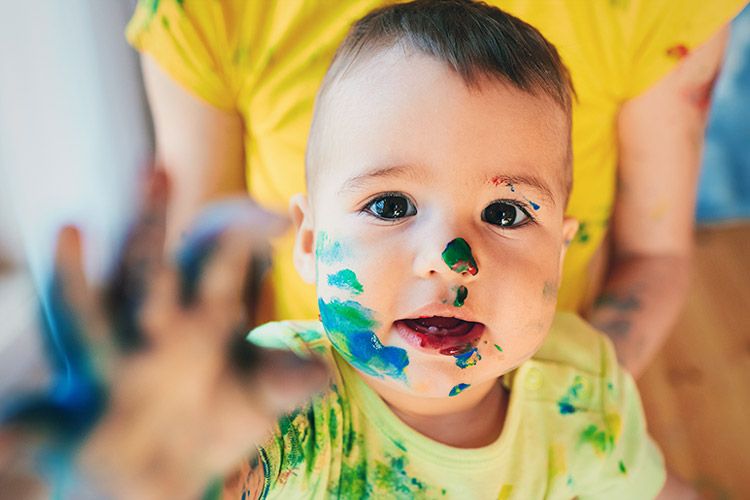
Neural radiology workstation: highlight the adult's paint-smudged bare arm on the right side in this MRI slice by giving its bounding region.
[589,28,729,377]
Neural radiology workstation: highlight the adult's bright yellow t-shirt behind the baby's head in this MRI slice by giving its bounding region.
[127,0,744,319]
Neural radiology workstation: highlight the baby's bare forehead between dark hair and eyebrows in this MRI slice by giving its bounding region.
[308,49,570,203]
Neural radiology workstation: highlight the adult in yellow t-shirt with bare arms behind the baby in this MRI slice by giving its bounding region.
[127,0,744,375]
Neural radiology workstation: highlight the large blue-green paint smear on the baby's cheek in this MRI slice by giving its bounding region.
[318,299,409,381]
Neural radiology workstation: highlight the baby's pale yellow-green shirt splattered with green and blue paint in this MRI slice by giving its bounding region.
[234,313,665,500]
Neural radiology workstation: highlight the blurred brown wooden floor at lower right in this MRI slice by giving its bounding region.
[638,223,750,500]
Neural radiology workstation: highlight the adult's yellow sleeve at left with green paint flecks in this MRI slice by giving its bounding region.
[125,0,245,110]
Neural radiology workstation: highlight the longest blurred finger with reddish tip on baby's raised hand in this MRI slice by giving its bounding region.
[105,170,169,351]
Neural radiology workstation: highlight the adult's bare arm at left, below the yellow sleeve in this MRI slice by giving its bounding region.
[141,55,245,248]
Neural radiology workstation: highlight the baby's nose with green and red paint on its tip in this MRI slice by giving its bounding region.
[414,237,479,282]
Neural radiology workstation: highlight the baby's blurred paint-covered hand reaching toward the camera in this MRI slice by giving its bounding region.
[4,172,327,499]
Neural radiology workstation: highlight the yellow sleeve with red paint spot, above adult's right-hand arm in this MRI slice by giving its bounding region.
[624,0,746,99]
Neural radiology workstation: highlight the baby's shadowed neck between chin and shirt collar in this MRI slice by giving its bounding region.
[368,377,508,448]
